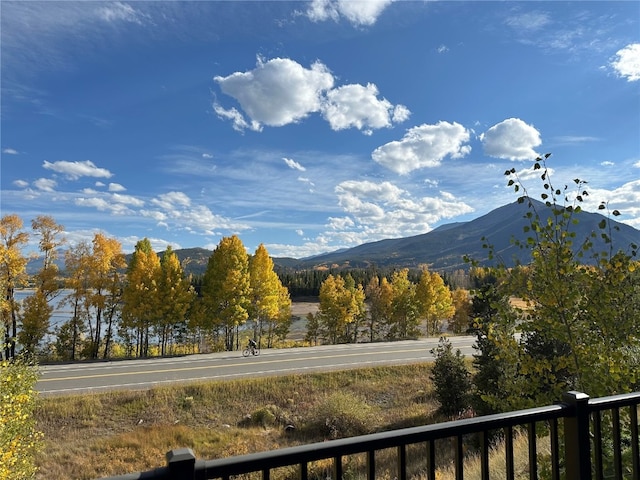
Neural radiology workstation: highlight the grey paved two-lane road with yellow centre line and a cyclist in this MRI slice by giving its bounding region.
[36,337,475,395]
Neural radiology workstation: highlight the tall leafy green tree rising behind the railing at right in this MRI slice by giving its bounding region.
[468,155,640,410]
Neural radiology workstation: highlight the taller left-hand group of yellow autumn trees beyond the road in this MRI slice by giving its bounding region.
[0,215,291,360]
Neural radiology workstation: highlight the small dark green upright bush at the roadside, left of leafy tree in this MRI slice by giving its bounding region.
[431,338,471,417]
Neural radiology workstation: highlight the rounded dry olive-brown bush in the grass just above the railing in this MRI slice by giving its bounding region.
[307,392,372,438]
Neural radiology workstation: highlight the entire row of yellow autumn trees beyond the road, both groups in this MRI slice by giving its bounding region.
[0,215,471,360]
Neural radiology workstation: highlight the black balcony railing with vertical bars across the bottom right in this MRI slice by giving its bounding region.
[101,392,640,480]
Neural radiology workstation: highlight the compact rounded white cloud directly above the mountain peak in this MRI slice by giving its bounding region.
[480,118,542,160]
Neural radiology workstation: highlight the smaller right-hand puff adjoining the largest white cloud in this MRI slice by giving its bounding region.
[322,83,410,133]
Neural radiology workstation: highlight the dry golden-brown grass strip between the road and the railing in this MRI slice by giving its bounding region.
[36,364,439,480]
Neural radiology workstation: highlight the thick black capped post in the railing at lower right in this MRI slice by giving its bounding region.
[562,391,591,479]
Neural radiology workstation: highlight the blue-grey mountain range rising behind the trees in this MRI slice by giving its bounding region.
[28,199,640,275]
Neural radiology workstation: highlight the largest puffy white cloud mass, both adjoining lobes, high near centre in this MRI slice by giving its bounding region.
[213,58,410,134]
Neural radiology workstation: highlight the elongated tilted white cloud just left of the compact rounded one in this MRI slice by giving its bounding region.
[371,121,471,174]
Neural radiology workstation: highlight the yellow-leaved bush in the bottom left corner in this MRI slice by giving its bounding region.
[0,358,42,480]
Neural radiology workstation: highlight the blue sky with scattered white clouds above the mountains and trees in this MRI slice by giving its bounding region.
[0,0,640,258]
